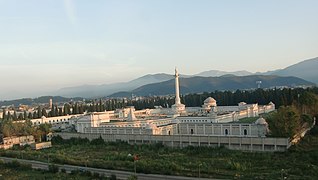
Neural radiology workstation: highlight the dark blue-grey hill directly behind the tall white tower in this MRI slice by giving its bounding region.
[111,75,314,97]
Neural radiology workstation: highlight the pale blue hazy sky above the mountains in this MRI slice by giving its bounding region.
[0,0,318,100]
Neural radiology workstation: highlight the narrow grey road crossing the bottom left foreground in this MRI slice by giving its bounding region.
[0,157,216,180]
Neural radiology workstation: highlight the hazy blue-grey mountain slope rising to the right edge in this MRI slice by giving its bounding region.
[268,57,318,84]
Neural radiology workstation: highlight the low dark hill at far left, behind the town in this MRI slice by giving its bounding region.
[0,96,83,107]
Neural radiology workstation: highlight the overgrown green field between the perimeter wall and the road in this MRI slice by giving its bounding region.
[0,126,318,179]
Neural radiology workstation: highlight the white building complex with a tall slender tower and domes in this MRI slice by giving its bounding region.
[74,69,275,137]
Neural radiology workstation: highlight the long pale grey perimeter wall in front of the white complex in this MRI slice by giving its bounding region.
[54,133,290,152]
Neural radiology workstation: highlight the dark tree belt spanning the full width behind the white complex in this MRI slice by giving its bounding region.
[3,87,318,121]
